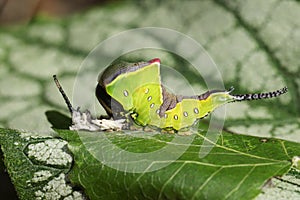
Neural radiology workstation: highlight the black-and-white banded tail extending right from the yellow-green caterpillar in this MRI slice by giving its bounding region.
[230,87,288,101]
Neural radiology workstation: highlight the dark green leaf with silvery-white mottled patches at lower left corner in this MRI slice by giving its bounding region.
[0,128,82,199]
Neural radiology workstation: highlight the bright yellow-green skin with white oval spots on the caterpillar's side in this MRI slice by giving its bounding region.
[99,60,234,130]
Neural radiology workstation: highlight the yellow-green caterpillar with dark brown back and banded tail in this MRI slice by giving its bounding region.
[96,58,287,131]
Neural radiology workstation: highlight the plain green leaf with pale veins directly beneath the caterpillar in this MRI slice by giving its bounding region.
[54,126,300,199]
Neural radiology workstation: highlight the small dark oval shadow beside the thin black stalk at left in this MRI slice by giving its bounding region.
[45,110,72,129]
